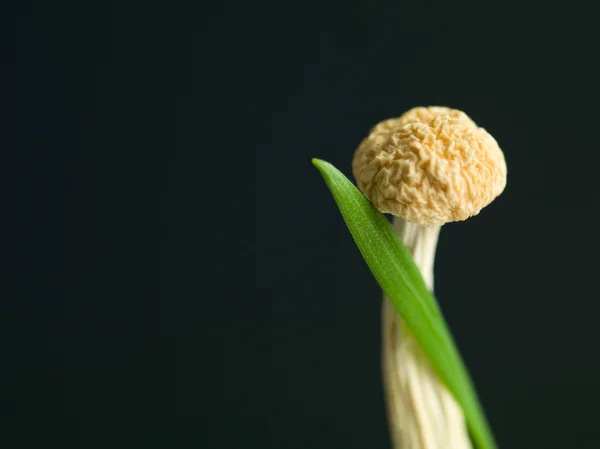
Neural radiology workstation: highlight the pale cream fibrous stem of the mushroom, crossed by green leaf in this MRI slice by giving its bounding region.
[382,217,472,449]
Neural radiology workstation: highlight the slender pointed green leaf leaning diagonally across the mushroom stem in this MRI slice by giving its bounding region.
[312,159,496,449]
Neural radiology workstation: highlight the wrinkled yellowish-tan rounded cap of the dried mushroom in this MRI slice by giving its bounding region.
[352,112,506,225]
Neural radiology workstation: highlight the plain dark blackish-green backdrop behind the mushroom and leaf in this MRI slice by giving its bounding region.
[8,1,600,449]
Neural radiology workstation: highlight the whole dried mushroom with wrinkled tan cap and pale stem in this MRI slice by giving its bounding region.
[352,106,506,449]
